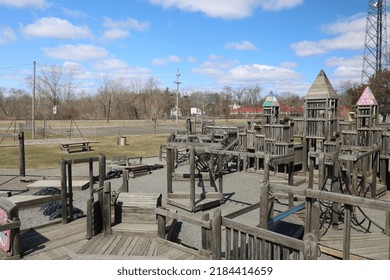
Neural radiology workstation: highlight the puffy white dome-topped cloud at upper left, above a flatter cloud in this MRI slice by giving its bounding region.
[21,17,93,39]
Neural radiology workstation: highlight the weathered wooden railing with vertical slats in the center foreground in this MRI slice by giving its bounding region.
[156,201,318,260]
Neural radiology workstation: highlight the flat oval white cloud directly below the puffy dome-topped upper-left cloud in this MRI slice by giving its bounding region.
[43,44,108,61]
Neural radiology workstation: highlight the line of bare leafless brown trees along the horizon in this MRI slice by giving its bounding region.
[0,66,314,123]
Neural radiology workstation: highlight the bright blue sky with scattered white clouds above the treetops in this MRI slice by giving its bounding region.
[0,0,380,96]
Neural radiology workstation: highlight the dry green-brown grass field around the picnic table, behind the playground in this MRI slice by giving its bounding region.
[0,119,246,169]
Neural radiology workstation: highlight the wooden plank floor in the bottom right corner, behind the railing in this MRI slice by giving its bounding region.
[319,230,390,260]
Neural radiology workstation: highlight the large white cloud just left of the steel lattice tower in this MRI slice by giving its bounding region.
[291,14,366,56]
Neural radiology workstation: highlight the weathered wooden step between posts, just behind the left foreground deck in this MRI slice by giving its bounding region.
[111,192,162,236]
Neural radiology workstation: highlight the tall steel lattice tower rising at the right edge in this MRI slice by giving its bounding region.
[362,0,389,84]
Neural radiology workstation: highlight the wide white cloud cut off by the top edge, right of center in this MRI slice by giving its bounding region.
[149,0,303,19]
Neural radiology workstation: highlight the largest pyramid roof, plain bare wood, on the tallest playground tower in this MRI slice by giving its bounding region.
[304,70,338,99]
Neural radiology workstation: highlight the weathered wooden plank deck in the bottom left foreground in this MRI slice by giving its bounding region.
[8,218,208,260]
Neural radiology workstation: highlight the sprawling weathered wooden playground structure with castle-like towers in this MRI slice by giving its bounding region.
[0,71,390,260]
